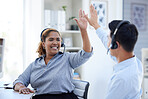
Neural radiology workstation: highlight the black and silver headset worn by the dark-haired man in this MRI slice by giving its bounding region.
[107,21,130,54]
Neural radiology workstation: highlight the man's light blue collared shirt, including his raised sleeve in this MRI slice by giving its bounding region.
[96,28,143,99]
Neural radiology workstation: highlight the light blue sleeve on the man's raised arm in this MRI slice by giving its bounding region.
[96,27,117,62]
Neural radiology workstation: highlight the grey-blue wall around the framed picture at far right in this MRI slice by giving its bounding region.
[124,0,148,59]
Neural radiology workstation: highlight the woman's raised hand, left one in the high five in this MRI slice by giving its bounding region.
[74,9,87,30]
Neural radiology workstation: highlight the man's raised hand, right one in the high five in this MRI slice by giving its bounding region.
[84,4,100,29]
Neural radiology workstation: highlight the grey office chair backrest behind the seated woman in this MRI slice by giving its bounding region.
[73,80,89,99]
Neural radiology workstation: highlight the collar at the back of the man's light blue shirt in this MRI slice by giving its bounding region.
[113,56,136,72]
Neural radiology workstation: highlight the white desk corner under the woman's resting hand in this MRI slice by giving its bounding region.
[0,88,33,99]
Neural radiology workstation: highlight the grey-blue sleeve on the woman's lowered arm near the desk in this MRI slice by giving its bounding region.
[13,64,32,87]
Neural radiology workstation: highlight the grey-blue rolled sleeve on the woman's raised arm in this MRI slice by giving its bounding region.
[69,48,93,69]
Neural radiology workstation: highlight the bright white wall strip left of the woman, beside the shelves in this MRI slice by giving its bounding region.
[23,0,44,69]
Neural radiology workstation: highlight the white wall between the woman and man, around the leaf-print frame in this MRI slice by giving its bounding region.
[81,0,122,99]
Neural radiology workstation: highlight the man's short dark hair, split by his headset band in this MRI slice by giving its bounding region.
[109,20,138,52]
